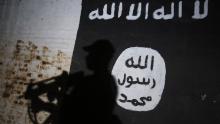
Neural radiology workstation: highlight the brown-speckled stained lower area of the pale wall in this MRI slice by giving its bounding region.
[0,40,71,124]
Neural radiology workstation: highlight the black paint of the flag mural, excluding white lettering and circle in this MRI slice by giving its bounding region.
[71,0,220,124]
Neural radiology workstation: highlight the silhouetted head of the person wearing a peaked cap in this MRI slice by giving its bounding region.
[84,39,114,72]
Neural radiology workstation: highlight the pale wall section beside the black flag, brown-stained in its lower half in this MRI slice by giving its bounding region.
[0,0,81,124]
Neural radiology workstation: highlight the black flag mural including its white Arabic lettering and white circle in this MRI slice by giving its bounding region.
[70,0,220,124]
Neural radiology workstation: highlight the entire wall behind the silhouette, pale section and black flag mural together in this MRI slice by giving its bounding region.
[0,0,220,124]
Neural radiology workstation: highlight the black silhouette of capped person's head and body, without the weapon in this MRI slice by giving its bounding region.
[60,40,120,124]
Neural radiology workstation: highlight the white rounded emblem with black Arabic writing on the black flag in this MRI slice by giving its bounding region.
[112,47,166,111]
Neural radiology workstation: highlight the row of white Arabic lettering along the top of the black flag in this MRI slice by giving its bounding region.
[88,0,208,21]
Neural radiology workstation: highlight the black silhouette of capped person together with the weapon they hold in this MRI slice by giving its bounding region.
[25,40,121,124]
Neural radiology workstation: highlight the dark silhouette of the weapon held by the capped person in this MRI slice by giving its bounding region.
[21,71,69,124]
